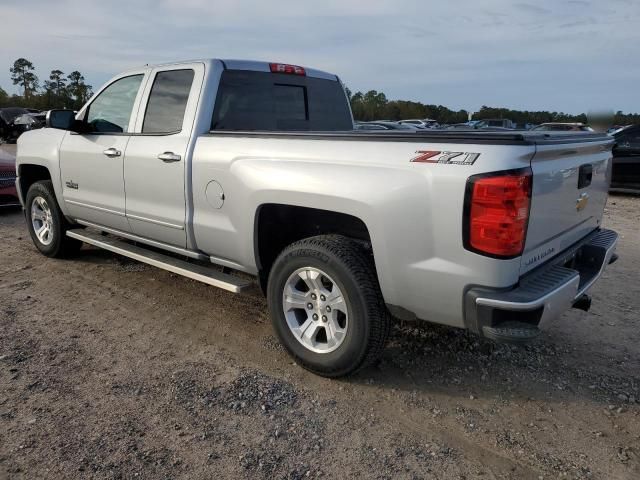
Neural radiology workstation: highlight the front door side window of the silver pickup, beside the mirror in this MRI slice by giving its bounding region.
[85,75,144,133]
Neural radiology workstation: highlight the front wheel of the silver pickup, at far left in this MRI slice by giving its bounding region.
[25,180,82,258]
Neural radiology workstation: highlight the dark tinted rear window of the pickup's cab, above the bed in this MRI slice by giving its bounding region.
[211,70,353,131]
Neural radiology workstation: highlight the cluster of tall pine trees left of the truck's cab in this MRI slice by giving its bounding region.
[0,58,93,110]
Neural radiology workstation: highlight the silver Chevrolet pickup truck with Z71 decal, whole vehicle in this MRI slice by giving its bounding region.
[16,60,617,376]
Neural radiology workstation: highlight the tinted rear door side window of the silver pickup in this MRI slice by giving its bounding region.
[142,70,194,133]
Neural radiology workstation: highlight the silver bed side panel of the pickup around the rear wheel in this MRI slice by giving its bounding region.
[192,134,533,326]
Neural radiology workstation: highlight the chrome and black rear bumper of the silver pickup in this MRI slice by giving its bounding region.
[465,230,618,341]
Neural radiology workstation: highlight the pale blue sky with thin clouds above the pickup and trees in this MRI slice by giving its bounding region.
[0,0,640,113]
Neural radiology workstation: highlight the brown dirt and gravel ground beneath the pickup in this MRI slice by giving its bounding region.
[0,144,640,479]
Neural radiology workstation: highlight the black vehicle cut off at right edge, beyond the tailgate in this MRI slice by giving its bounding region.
[611,125,640,193]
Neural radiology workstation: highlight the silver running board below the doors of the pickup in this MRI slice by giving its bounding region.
[67,228,253,293]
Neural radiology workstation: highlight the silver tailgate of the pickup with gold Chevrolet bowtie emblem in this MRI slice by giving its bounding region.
[520,134,612,274]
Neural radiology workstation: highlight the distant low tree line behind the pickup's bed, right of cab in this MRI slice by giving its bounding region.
[347,88,640,125]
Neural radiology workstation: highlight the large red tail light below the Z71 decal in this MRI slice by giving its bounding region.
[463,168,532,258]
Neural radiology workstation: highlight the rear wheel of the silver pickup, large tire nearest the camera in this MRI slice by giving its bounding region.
[267,235,390,377]
